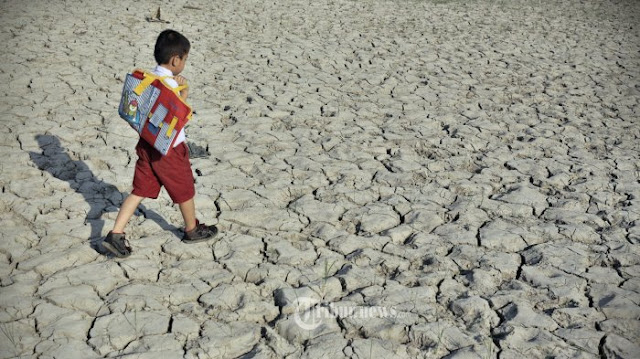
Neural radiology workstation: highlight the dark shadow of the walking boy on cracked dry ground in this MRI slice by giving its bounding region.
[29,135,177,254]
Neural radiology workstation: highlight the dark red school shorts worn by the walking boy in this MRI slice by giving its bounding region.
[131,138,196,203]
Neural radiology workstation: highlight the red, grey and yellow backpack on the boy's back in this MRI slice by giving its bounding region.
[118,70,192,155]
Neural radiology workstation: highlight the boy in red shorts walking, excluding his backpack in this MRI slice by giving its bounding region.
[102,30,218,257]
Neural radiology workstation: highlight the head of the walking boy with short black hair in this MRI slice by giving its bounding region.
[153,30,191,75]
